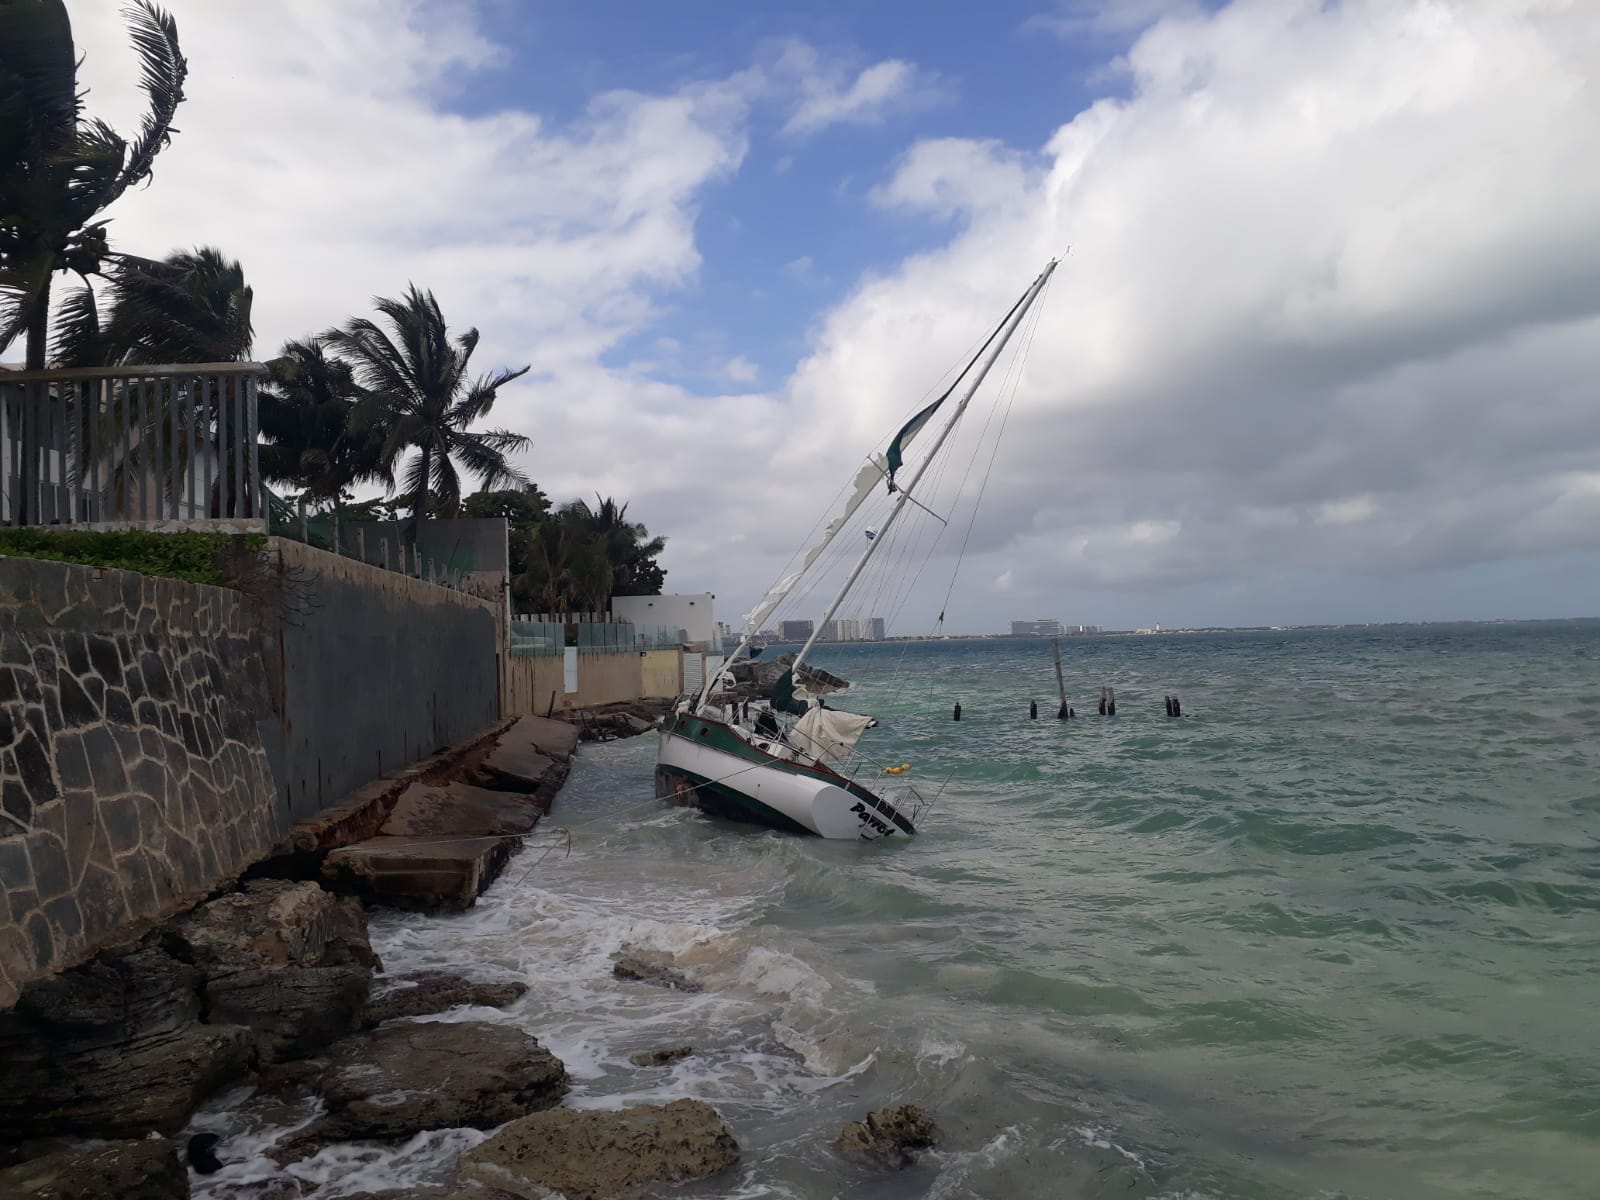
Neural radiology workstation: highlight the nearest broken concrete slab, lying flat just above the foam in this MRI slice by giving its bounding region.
[322,837,522,910]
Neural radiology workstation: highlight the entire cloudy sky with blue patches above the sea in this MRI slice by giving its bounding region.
[69,0,1600,632]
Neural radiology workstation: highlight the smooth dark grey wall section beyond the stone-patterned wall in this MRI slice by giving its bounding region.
[266,538,496,819]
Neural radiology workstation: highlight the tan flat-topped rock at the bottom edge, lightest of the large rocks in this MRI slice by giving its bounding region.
[456,1099,739,1200]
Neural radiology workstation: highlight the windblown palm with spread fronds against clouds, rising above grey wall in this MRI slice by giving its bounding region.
[323,283,528,541]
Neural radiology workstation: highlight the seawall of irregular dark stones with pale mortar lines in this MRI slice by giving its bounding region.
[0,557,290,1010]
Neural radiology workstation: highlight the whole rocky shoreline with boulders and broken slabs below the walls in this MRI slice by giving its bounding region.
[0,714,933,1200]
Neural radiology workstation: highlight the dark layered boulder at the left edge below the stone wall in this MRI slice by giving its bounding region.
[0,946,256,1141]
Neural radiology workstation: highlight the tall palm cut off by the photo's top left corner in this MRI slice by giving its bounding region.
[0,0,189,370]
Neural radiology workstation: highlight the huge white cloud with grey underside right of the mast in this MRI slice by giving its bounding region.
[768,0,1600,627]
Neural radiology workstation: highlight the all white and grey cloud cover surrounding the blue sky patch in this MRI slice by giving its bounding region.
[65,0,1600,629]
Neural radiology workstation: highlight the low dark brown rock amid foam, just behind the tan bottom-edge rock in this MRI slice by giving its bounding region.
[272,1021,570,1162]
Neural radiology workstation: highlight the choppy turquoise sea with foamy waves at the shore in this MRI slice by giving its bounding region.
[196,622,1600,1200]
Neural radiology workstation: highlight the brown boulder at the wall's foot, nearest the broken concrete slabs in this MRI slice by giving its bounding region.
[170,880,378,1062]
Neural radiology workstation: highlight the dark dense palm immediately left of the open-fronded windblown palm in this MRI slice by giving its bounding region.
[259,338,394,499]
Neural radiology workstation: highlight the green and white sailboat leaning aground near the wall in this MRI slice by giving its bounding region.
[656,259,1056,842]
